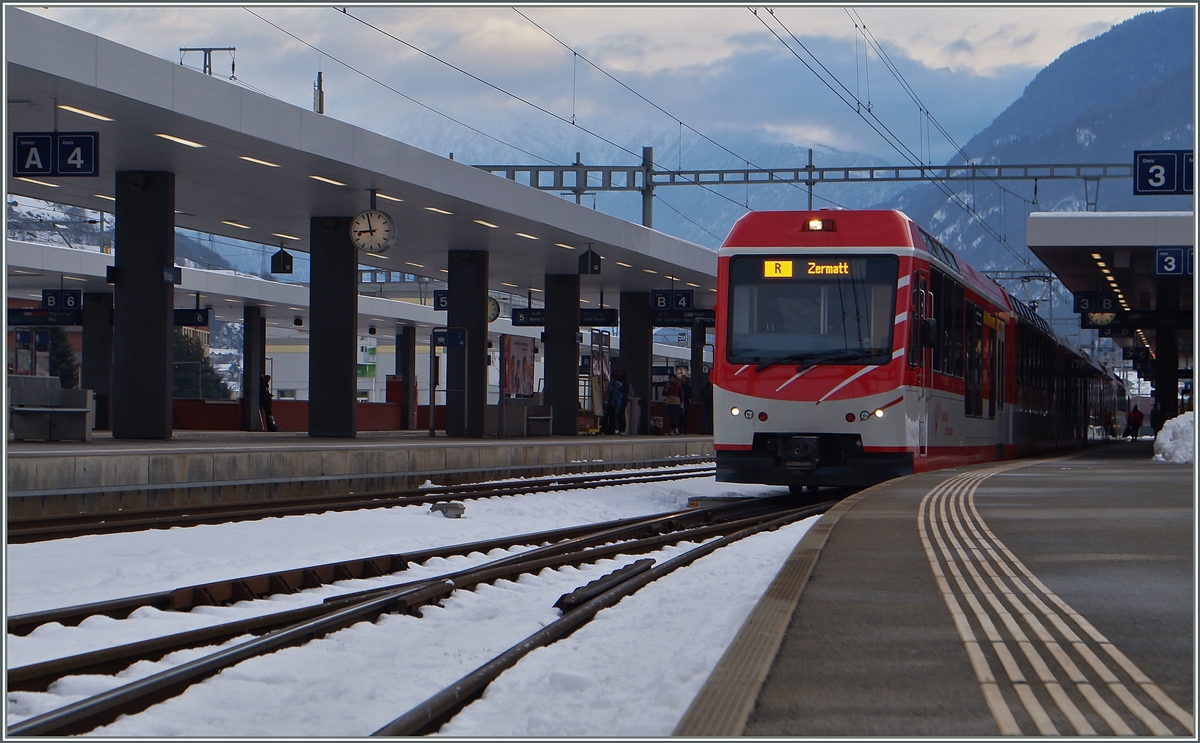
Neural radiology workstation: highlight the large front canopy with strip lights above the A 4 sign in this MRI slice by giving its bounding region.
[5,7,716,306]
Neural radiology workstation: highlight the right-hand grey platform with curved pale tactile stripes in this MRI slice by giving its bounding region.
[676,442,1195,737]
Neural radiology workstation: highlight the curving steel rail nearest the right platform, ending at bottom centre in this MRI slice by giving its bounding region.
[371,503,833,736]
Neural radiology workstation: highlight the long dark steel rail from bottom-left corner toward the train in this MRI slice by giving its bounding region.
[7,496,811,736]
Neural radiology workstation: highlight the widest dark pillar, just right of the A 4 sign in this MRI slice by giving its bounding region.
[109,170,175,438]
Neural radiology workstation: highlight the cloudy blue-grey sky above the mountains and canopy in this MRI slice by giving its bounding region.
[31,5,1158,167]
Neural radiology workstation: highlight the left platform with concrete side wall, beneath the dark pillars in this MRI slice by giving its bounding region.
[6,431,713,520]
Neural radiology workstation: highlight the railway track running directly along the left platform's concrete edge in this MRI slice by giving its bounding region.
[7,465,715,544]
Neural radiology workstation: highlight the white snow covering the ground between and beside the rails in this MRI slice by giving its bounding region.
[6,478,815,737]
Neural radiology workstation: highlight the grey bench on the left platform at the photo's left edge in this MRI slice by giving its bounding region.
[8,375,95,442]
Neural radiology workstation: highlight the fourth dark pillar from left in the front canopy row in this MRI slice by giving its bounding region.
[542,274,580,436]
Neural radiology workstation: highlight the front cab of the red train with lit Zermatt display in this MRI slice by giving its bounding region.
[714,212,932,490]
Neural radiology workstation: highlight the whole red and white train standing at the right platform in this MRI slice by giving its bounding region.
[712,210,1126,492]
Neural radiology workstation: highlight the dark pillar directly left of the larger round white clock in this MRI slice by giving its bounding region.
[308,217,359,438]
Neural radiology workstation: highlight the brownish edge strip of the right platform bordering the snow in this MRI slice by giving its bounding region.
[671,475,913,737]
